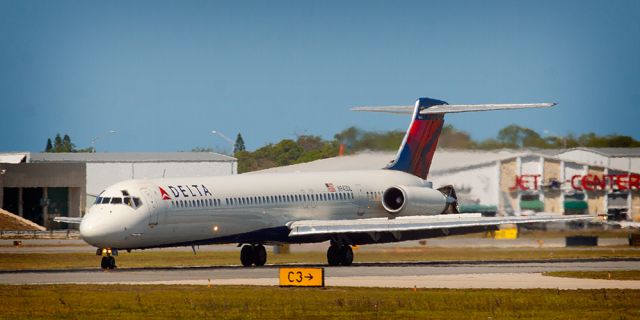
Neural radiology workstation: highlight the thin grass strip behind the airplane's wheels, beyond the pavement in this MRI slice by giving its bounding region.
[0,247,640,270]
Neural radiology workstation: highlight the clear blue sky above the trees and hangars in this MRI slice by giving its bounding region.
[0,0,640,152]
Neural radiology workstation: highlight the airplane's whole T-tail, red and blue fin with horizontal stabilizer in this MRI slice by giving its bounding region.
[351,98,556,179]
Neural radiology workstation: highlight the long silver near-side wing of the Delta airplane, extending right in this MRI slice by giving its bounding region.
[288,213,594,237]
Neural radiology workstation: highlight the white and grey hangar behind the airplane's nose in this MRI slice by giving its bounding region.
[0,152,238,227]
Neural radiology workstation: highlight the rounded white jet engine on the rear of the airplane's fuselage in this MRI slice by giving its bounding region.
[382,186,451,216]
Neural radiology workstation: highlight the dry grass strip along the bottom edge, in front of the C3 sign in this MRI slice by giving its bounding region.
[0,285,640,320]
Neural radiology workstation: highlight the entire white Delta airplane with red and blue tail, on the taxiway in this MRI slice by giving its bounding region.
[56,98,592,269]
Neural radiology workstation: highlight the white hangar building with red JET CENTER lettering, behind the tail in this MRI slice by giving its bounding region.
[256,148,640,221]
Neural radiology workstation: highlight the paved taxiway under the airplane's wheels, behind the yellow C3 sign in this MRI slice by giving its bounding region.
[5,259,640,290]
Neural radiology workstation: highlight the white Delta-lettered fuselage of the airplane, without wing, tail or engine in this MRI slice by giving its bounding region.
[80,170,444,249]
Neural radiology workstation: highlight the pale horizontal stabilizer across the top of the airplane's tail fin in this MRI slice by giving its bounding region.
[351,103,556,114]
